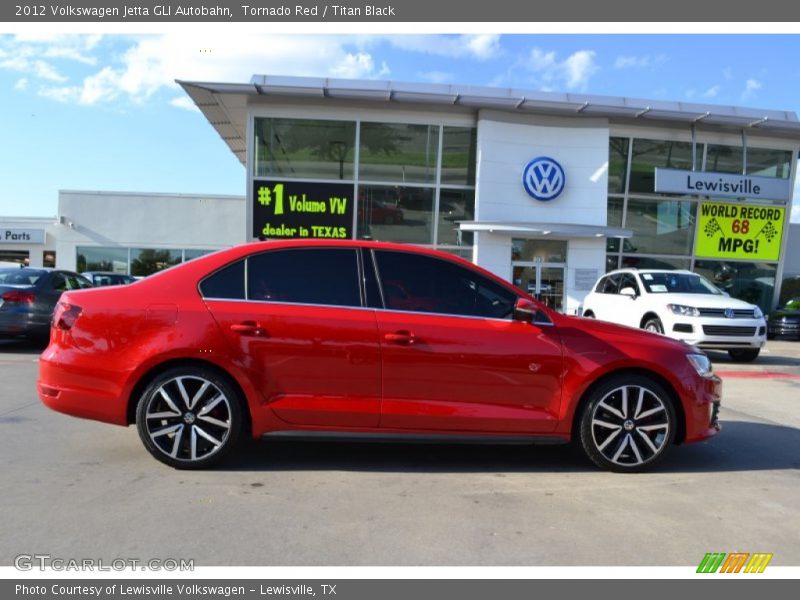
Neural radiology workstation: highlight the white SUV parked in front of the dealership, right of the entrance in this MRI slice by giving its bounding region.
[581,269,767,361]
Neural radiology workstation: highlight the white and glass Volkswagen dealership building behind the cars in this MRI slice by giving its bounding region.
[0,75,800,314]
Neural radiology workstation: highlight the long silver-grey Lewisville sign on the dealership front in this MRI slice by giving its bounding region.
[655,168,792,200]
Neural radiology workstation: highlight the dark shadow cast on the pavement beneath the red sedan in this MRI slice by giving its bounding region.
[219,421,800,473]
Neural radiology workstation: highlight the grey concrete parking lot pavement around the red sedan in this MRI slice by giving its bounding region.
[0,342,800,566]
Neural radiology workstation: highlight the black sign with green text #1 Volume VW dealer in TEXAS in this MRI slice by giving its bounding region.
[252,179,353,240]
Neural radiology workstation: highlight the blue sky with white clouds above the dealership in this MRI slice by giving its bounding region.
[0,30,800,222]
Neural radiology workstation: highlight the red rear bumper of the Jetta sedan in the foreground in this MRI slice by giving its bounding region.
[36,348,128,425]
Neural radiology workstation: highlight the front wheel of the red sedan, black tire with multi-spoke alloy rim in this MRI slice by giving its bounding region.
[578,374,677,473]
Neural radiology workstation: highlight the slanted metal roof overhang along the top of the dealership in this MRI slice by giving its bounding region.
[178,75,800,169]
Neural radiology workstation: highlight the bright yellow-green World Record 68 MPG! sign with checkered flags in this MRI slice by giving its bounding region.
[695,202,786,261]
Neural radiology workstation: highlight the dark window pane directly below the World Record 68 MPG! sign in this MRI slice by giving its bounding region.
[694,260,778,313]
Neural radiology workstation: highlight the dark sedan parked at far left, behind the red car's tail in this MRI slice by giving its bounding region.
[0,267,92,339]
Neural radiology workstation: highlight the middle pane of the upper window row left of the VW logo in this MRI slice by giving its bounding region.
[358,123,439,184]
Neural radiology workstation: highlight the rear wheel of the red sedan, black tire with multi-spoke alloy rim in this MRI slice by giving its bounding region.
[136,366,244,469]
